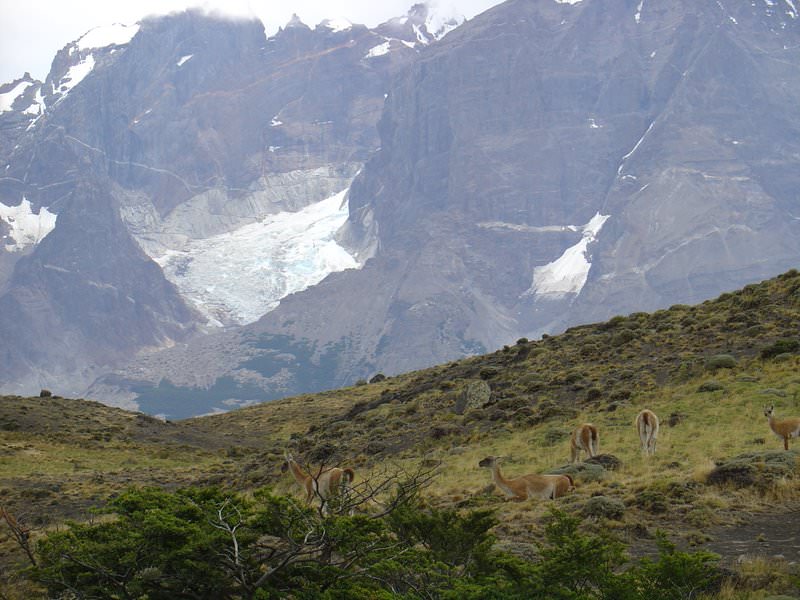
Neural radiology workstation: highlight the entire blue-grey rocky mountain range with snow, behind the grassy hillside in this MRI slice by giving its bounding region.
[0,0,800,417]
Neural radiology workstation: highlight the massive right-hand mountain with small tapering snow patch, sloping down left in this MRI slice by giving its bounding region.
[101,0,800,414]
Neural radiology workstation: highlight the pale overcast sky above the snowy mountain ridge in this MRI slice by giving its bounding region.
[0,0,500,84]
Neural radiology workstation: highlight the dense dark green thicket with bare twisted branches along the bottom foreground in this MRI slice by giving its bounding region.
[30,484,716,600]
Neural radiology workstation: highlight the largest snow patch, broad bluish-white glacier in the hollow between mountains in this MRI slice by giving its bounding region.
[154,190,360,326]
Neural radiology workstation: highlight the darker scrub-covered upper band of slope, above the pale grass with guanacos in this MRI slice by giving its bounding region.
[211,271,800,461]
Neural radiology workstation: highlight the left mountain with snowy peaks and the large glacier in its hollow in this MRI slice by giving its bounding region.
[0,6,444,393]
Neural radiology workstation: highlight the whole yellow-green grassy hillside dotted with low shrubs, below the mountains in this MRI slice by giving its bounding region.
[0,271,800,587]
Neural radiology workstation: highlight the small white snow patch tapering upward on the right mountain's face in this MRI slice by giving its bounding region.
[523,212,609,299]
